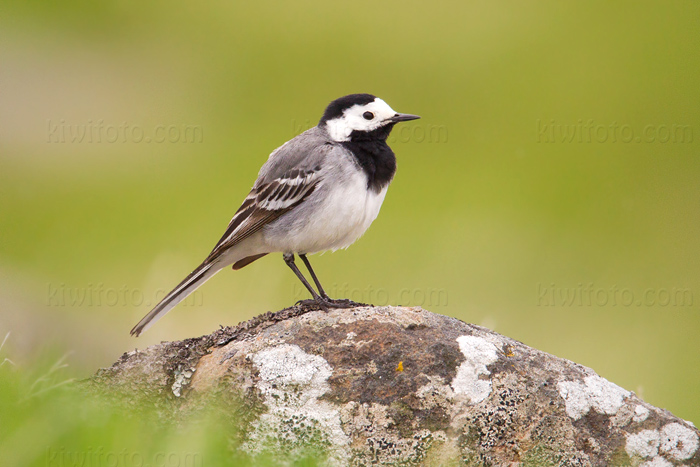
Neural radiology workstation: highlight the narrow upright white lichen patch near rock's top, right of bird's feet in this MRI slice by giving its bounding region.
[451,336,498,404]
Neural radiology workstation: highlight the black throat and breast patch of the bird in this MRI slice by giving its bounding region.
[340,123,396,193]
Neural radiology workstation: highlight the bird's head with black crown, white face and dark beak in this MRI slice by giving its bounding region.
[318,94,420,142]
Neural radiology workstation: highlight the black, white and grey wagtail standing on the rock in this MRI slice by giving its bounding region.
[131,94,420,336]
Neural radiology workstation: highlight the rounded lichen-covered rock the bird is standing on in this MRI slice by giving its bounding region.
[89,307,700,466]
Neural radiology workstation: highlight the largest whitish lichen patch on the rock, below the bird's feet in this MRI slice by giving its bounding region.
[244,344,348,464]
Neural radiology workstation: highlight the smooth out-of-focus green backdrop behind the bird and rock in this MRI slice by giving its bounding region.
[0,1,700,432]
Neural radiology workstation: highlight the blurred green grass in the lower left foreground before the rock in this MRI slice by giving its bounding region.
[0,346,323,467]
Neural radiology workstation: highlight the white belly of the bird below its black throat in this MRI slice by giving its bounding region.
[264,172,387,253]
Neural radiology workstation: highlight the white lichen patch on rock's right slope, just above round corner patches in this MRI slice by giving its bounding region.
[557,375,630,420]
